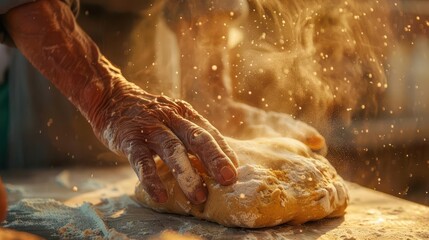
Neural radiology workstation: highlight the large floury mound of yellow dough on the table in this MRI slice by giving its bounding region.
[135,138,349,228]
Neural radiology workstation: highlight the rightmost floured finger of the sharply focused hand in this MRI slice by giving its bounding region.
[170,115,237,185]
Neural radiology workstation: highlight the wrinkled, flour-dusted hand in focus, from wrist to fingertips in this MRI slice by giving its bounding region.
[89,80,237,204]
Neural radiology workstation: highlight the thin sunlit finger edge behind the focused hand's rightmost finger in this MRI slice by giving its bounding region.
[192,116,238,167]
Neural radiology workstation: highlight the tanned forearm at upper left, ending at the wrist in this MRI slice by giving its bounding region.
[3,0,123,120]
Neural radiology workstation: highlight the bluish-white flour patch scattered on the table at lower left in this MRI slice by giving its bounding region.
[3,198,129,239]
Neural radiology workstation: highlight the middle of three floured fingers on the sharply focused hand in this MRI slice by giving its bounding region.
[148,125,207,204]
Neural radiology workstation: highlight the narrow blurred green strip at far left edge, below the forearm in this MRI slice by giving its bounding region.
[0,77,9,169]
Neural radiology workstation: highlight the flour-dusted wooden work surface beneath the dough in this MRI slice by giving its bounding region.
[1,166,429,240]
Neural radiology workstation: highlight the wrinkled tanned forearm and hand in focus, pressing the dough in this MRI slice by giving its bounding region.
[2,0,237,204]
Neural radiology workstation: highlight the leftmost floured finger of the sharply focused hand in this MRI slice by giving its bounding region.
[124,141,168,203]
